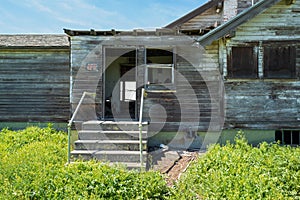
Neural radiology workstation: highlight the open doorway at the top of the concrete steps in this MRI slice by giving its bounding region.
[103,48,136,120]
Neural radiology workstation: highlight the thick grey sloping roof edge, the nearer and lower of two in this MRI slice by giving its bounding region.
[197,0,281,46]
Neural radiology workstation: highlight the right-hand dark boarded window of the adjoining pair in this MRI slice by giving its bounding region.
[264,46,296,78]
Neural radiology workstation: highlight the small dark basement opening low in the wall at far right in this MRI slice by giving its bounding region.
[275,130,300,145]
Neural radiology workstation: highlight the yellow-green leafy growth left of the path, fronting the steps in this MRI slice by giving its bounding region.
[0,127,170,199]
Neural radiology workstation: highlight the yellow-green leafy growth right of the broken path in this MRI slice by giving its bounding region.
[174,131,300,199]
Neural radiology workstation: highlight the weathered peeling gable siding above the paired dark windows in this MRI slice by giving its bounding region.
[232,0,300,42]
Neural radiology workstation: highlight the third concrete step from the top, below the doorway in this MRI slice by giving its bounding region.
[75,140,147,151]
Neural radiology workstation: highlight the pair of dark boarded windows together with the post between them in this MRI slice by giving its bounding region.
[225,41,297,79]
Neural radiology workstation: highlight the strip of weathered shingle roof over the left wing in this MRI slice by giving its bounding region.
[0,34,70,47]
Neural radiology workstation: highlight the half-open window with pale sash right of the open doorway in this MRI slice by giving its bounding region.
[145,49,175,89]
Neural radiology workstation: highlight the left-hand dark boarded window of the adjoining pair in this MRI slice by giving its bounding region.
[228,47,257,78]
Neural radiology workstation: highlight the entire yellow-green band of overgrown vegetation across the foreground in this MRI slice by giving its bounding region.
[0,127,300,199]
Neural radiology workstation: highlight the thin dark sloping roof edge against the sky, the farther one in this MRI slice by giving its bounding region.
[165,0,224,28]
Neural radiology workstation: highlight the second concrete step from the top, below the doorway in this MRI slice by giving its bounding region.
[78,130,147,140]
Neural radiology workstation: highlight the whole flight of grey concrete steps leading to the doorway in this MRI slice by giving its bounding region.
[71,120,149,169]
